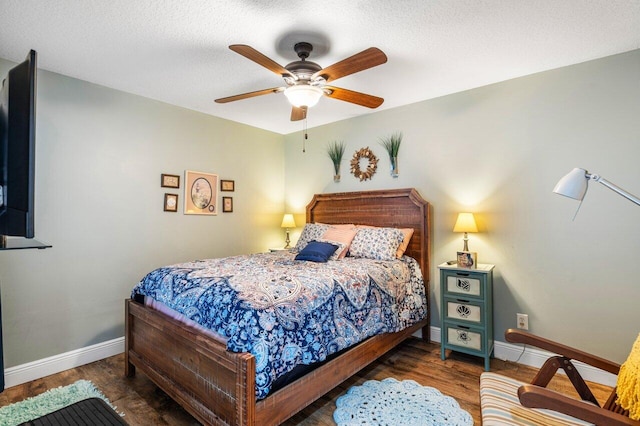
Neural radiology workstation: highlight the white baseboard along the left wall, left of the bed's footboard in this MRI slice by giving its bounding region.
[4,337,124,388]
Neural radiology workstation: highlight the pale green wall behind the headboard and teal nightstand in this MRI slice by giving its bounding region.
[285,50,640,361]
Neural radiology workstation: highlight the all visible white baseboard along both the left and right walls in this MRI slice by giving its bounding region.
[4,327,616,388]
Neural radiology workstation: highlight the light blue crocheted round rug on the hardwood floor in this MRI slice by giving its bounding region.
[333,378,473,426]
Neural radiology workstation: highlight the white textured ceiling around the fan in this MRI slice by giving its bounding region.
[0,0,640,134]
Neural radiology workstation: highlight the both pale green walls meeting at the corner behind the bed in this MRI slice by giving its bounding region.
[0,51,640,367]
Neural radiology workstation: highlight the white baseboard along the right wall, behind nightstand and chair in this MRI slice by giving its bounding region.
[420,327,617,387]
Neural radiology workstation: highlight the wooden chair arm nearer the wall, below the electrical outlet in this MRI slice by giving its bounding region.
[504,328,620,375]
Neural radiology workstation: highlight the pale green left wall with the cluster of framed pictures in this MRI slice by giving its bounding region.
[0,60,284,367]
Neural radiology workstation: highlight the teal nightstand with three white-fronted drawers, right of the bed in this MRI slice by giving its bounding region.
[438,263,495,371]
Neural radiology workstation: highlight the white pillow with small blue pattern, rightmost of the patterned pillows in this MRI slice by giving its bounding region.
[349,228,404,260]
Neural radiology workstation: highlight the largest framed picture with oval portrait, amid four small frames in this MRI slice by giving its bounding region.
[184,170,218,216]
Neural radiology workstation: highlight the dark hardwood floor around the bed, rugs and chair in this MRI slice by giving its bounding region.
[0,338,611,426]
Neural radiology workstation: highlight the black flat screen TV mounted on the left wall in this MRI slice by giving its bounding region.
[0,50,37,241]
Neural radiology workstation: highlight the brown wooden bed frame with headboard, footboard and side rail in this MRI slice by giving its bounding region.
[125,189,430,426]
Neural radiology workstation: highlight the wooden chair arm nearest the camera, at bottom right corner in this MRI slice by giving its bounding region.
[518,385,640,426]
